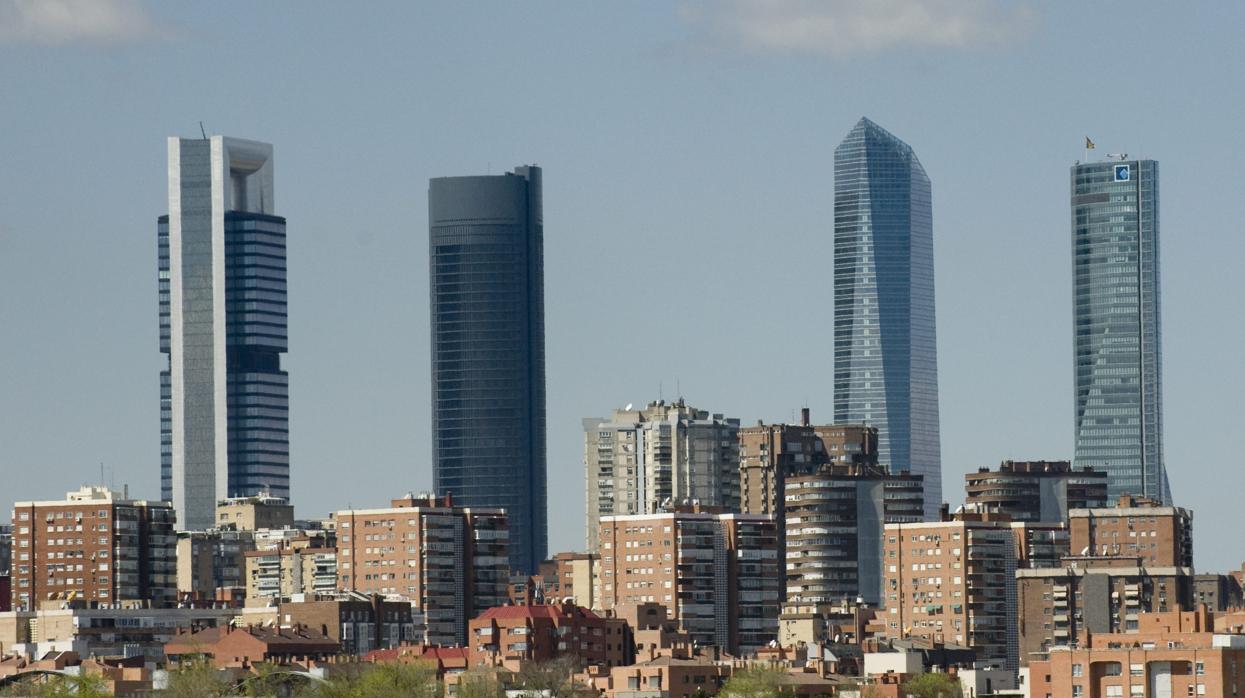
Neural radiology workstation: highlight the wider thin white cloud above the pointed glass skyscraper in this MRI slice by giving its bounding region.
[682,0,1032,56]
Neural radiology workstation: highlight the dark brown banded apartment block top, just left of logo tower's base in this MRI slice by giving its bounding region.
[964,460,1107,524]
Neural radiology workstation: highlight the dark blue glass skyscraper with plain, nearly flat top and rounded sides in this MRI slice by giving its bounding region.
[428,167,548,574]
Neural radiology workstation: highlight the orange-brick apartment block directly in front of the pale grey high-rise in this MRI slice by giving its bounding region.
[596,506,782,653]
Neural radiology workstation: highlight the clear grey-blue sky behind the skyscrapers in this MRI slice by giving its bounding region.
[0,0,1245,571]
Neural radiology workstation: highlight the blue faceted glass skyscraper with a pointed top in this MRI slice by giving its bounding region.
[834,118,942,519]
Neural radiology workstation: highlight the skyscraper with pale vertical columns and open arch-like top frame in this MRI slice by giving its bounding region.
[157,136,290,530]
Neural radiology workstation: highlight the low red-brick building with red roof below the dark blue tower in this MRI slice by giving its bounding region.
[468,603,635,668]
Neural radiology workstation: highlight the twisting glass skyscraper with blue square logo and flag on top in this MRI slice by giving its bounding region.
[1072,161,1172,504]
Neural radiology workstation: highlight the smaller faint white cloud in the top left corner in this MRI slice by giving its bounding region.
[0,0,167,45]
